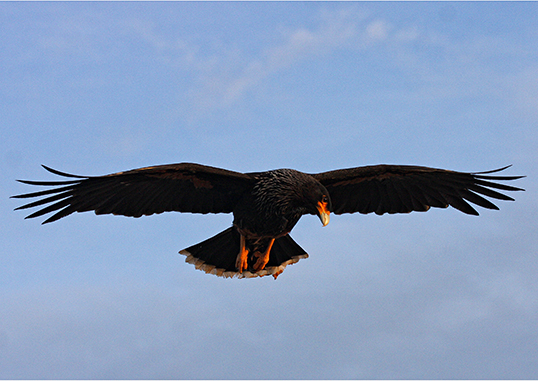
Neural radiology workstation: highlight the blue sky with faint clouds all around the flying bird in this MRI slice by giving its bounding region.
[0,2,538,379]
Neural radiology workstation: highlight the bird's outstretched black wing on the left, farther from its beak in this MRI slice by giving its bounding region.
[13,163,253,223]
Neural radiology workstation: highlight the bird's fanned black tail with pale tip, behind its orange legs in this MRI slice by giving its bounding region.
[179,227,308,279]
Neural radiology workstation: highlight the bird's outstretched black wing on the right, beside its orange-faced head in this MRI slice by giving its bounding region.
[312,165,524,215]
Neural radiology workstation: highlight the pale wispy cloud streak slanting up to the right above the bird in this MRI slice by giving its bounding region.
[182,8,417,113]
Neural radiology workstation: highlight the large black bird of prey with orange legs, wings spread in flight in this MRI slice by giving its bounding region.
[12,163,525,279]
